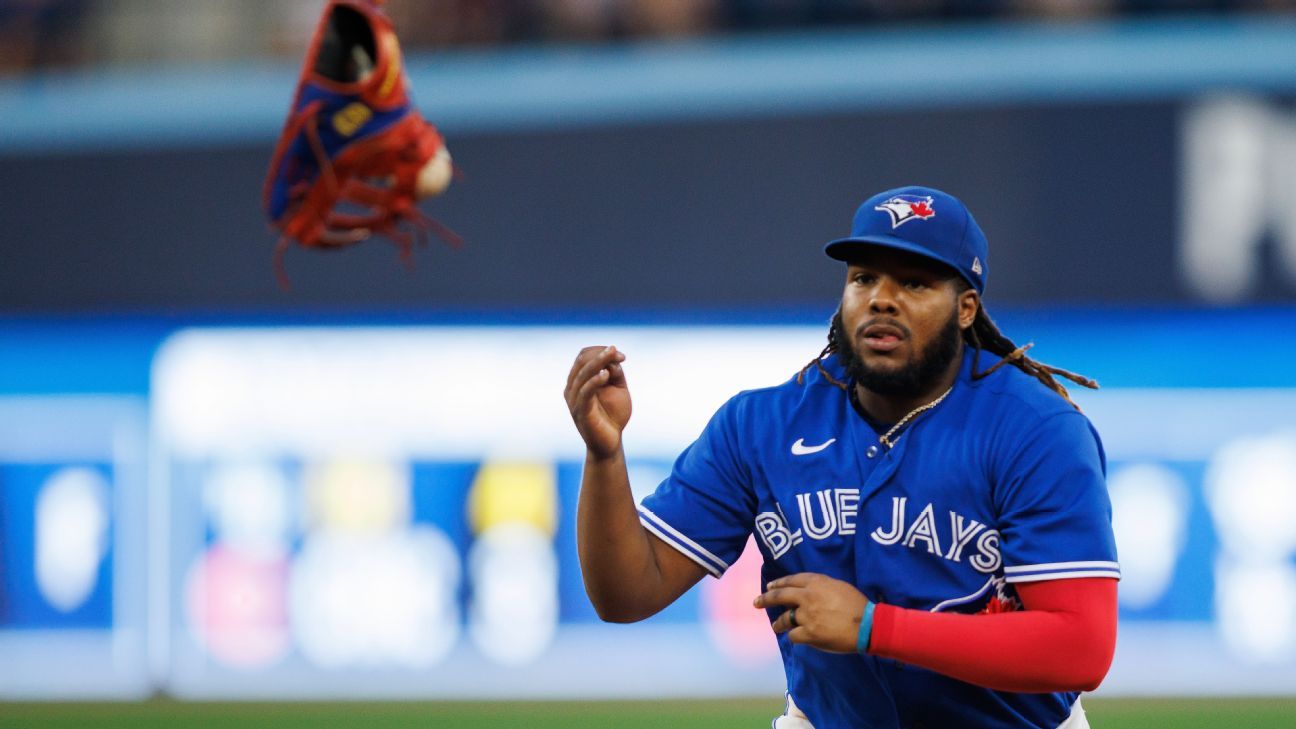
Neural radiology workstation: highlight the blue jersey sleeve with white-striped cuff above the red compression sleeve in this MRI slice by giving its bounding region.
[995,411,1121,582]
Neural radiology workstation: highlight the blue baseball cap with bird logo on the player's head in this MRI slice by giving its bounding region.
[823,187,990,294]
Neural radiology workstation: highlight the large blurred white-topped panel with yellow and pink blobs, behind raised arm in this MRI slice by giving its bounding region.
[153,327,803,698]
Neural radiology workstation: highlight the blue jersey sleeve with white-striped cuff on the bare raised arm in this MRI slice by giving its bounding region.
[639,400,756,577]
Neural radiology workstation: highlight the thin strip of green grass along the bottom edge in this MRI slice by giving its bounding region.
[0,698,1296,729]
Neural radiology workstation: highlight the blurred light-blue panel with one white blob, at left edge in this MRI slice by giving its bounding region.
[0,396,153,698]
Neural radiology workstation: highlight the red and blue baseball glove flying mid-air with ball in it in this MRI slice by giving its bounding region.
[263,0,460,288]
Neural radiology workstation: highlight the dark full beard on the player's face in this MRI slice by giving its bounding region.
[832,309,963,397]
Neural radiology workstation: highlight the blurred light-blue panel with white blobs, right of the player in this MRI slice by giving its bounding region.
[1078,388,1296,695]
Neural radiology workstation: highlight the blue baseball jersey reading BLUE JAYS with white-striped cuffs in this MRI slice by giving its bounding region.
[639,350,1120,729]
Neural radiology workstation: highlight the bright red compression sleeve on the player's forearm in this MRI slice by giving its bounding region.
[868,577,1116,693]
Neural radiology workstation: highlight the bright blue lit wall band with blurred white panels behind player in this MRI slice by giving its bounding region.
[0,307,1296,698]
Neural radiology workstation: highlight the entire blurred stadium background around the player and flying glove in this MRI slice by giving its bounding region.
[0,0,1296,728]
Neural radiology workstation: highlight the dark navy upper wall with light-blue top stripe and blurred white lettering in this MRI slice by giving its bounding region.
[0,17,1296,308]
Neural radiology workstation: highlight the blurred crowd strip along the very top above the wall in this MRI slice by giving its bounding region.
[0,0,1296,74]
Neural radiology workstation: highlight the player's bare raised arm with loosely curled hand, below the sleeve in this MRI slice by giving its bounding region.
[564,346,706,623]
